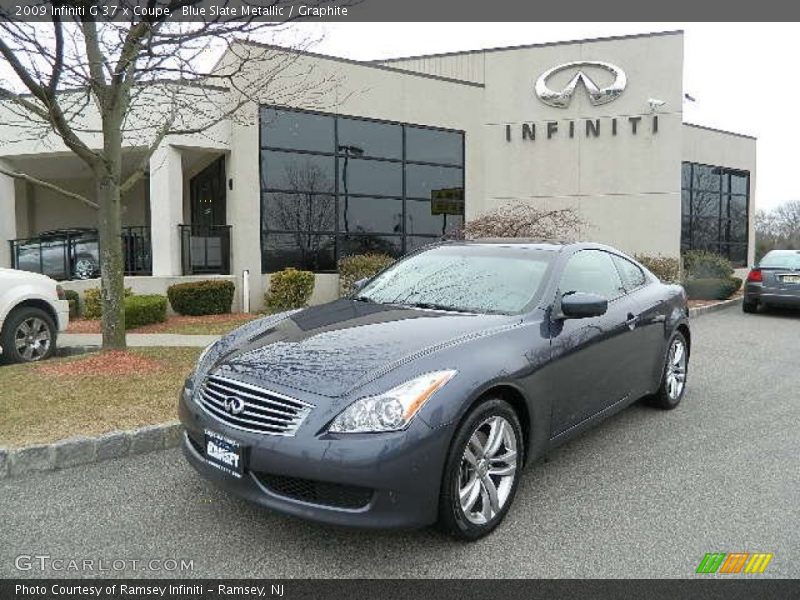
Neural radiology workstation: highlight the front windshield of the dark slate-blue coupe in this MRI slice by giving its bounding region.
[356,244,555,313]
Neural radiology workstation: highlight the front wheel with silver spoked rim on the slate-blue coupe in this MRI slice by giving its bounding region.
[439,399,524,541]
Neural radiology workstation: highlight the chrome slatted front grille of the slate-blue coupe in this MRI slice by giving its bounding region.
[198,375,313,435]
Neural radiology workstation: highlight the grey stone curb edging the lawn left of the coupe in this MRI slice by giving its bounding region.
[0,421,183,480]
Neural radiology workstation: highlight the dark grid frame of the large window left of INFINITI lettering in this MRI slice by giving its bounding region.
[258,104,467,273]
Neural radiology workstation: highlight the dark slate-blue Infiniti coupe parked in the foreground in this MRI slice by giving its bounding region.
[179,240,690,540]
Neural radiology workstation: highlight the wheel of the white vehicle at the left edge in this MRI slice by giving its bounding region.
[0,306,56,363]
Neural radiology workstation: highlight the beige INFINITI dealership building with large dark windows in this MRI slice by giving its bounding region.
[0,32,756,309]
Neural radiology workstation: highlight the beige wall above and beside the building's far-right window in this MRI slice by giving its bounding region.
[683,124,756,265]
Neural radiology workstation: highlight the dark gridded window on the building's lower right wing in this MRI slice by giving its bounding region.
[681,162,750,267]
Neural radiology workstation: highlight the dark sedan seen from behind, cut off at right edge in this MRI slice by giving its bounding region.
[742,250,800,313]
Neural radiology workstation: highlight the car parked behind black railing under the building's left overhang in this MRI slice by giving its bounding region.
[16,227,100,279]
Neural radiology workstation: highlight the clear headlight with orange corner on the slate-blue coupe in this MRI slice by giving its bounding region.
[329,370,457,433]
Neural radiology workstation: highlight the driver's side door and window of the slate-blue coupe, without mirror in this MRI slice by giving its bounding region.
[548,249,635,437]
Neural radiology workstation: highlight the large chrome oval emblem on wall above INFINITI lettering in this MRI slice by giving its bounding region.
[534,60,628,108]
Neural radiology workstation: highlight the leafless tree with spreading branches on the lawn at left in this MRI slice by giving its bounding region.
[0,0,338,348]
